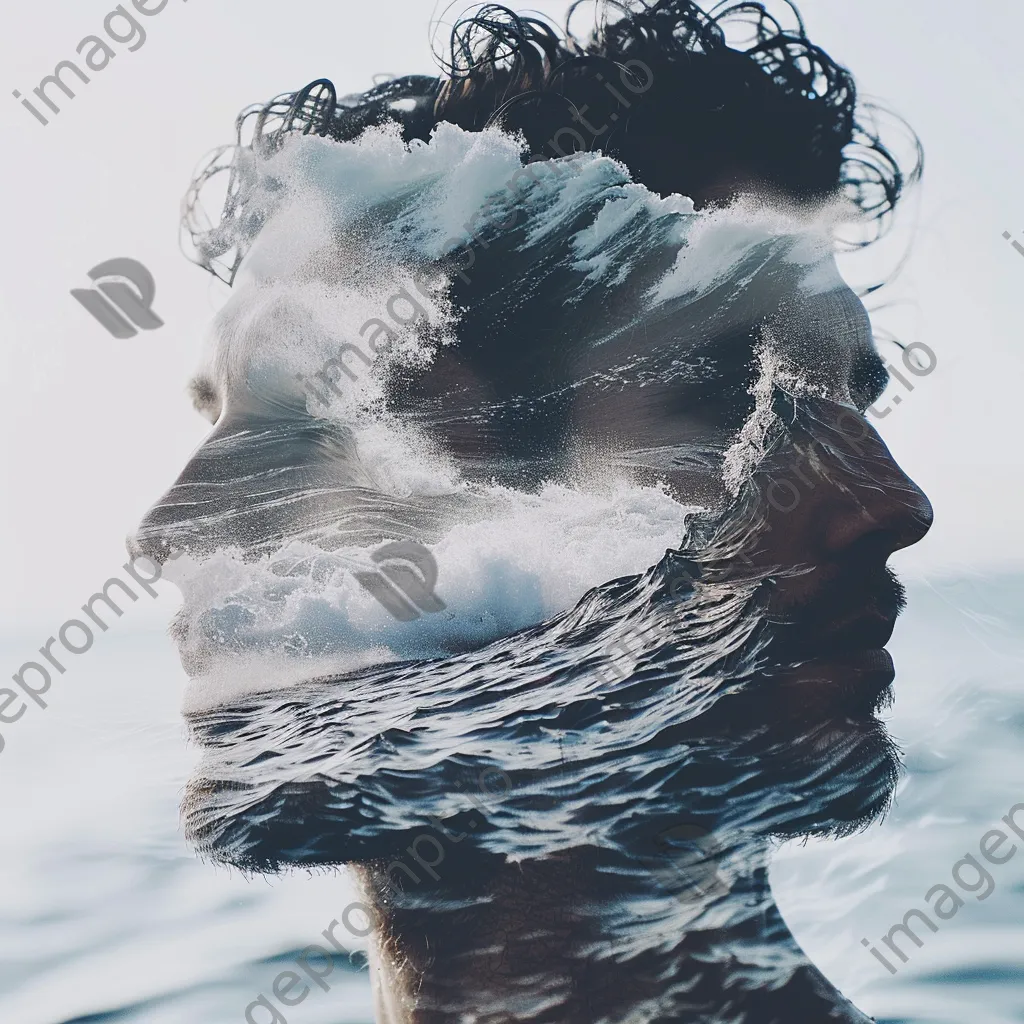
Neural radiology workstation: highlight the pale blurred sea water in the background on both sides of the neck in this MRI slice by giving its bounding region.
[0,578,1024,1024]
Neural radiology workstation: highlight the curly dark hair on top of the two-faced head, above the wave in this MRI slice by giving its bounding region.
[183,0,923,282]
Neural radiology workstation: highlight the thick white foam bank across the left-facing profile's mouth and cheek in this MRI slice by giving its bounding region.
[174,481,692,701]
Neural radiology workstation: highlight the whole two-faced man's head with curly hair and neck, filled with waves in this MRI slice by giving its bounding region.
[133,0,932,1022]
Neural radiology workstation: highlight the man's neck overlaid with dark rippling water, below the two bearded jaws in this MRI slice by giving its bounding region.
[361,845,869,1024]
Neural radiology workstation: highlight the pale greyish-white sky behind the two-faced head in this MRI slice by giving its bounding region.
[0,0,1024,626]
